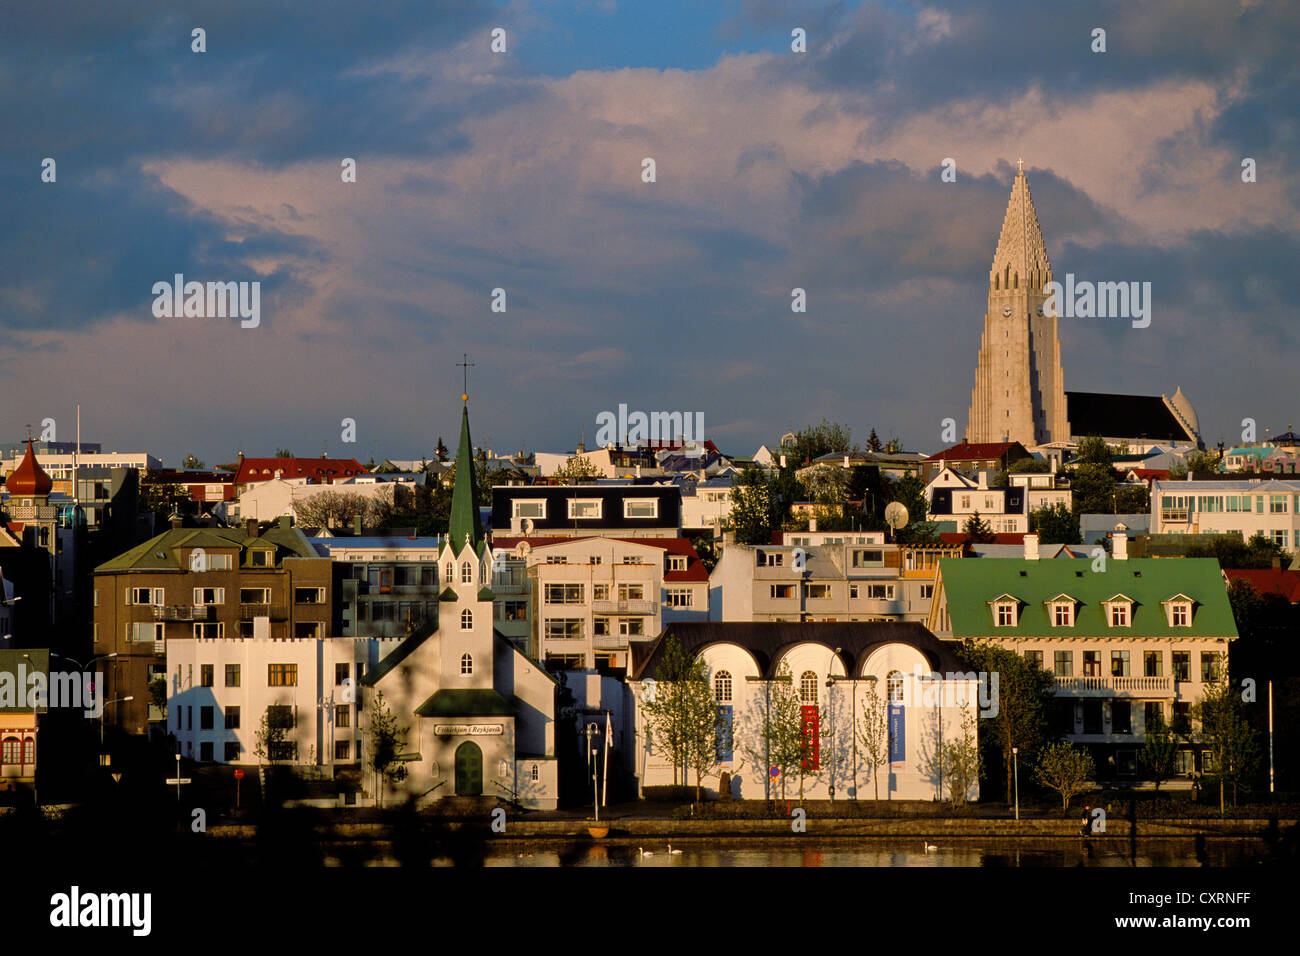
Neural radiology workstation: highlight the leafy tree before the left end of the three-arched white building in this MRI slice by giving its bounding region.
[645,637,718,801]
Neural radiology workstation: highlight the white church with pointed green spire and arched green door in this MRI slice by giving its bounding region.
[361,395,559,809]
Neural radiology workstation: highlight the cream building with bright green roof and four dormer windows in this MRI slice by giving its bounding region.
[928,548,1238,779]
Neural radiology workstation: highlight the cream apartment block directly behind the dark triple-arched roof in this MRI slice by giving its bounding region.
[709,532,962,622]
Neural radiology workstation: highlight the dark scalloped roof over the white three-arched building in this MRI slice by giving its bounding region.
[632,620,969,680]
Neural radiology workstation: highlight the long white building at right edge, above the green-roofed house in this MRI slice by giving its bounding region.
[1151,479,1300,549]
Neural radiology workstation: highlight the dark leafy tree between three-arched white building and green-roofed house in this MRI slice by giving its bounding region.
[962,640,1056,803]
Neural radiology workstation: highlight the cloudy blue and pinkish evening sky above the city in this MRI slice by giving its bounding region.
[0,0,1300,466]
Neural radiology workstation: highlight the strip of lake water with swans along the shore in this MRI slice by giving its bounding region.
[325,836,1264,868]
